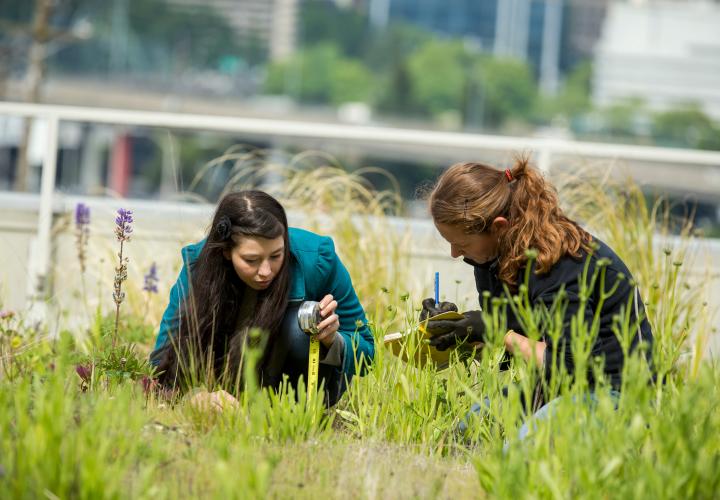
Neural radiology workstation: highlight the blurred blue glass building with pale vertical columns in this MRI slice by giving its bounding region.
[368,0,607,95]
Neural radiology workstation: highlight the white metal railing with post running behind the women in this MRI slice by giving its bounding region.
[0,102,720,324]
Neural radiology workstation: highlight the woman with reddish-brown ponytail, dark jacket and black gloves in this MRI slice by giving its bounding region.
[421,158,653,422]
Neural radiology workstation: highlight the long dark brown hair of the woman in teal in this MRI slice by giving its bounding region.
[158,191,290,388]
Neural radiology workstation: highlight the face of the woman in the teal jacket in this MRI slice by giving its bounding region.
[225,236,285,290]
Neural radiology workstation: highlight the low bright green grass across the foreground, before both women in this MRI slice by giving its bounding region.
[0,306,720,498]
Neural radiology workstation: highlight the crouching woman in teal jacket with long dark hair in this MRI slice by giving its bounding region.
[151,191,374,404]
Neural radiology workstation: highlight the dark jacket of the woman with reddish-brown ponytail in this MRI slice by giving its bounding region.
[466,238,653,389]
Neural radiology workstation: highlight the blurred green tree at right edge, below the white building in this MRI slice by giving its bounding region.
[652,104,720,149]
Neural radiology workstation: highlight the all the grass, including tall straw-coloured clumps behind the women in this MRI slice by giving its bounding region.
[0,163,720,499]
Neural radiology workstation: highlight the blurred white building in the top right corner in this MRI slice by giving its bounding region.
[593,0,720,119]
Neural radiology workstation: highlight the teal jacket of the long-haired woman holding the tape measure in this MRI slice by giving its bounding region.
[155,227,375,378]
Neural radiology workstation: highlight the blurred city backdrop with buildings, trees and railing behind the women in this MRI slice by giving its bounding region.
[0,0,720,344]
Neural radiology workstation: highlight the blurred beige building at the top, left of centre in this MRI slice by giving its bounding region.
[168,0,298,60]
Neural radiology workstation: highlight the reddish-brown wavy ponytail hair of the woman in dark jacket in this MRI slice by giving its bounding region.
[430,156,592,289]
